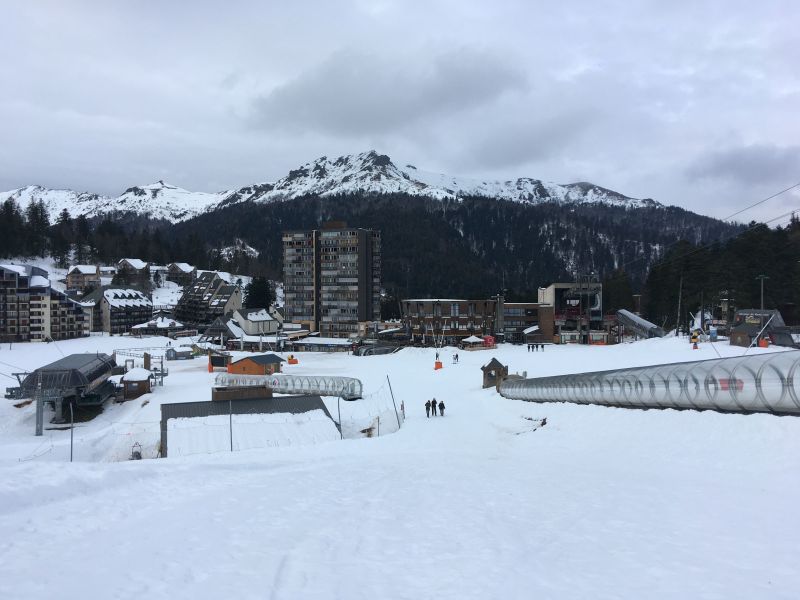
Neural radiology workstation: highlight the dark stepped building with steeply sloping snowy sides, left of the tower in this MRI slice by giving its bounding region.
[175,271,242,329]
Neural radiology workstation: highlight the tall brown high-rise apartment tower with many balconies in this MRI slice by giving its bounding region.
[283,222,381,337]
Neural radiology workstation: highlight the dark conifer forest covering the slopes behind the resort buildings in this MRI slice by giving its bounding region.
[0,194,800,326]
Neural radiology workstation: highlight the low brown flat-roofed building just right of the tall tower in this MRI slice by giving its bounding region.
[401,298,498,345]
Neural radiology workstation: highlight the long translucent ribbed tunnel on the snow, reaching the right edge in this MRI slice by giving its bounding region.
[500,351,800,415]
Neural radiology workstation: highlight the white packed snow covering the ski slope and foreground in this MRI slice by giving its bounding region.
[0,336,800,599]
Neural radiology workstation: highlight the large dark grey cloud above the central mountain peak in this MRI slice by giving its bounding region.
[250,48,526,136]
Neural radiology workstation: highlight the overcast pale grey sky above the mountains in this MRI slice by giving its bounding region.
[0,0,800,223]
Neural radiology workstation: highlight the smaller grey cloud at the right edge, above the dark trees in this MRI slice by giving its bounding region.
[686,144,800,186]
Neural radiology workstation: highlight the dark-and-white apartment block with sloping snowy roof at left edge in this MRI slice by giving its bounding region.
[0,265,88,342]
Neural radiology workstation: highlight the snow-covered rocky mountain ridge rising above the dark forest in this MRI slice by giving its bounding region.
[0,150,660,223]
